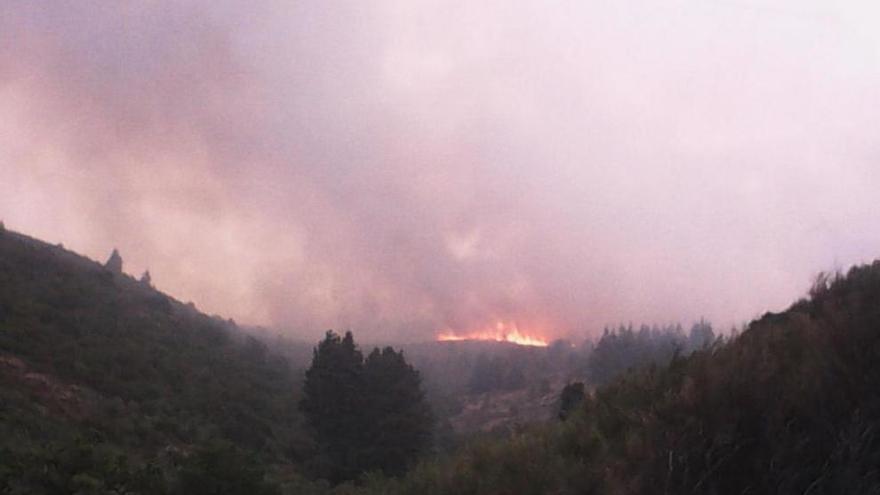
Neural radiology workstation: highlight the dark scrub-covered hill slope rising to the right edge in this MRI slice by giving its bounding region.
[370,262,880,495]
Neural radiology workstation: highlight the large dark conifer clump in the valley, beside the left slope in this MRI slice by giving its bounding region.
[300,331,432,482]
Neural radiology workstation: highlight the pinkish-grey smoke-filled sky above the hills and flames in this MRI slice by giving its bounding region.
[0,0,880,340]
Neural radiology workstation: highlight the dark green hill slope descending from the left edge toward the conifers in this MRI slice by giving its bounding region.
[0,231,307,493]
